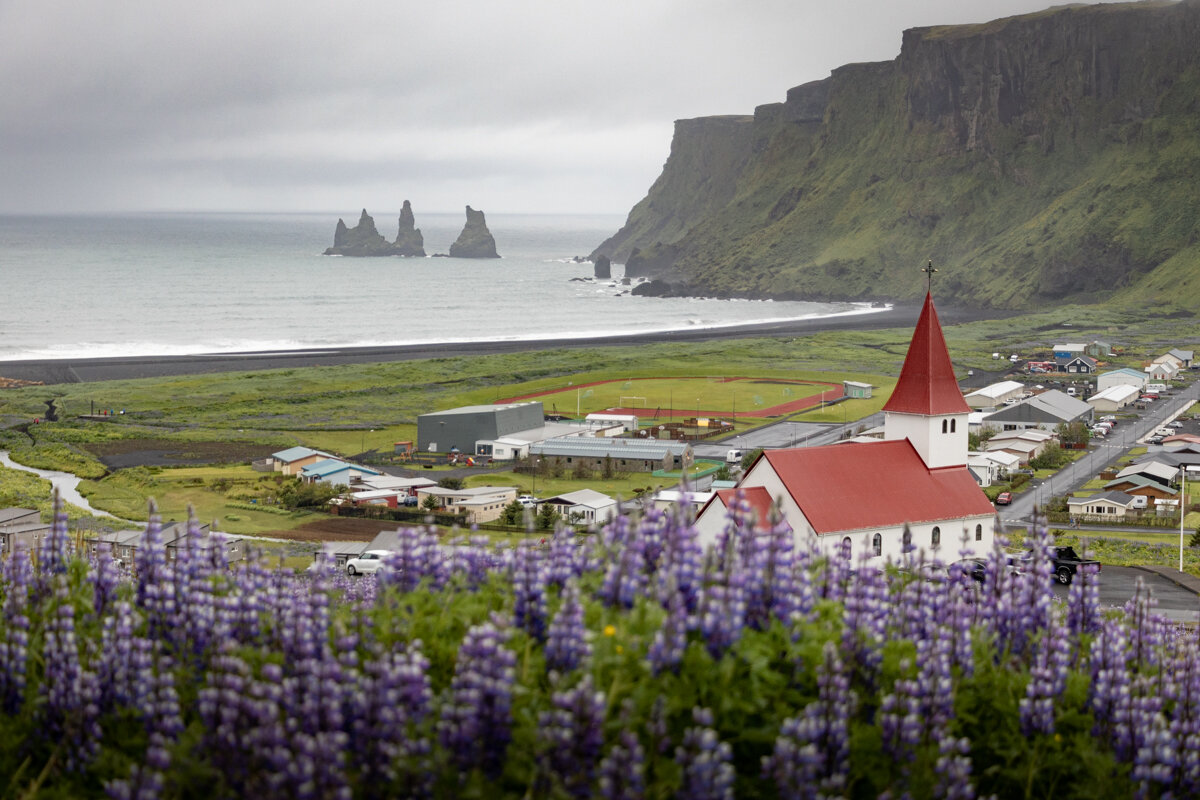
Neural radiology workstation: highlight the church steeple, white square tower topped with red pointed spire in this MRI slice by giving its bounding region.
[883,293,971,469]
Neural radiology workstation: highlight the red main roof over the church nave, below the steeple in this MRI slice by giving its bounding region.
[750,439,996,534]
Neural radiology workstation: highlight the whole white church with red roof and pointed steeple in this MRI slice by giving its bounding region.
[696,294,996,565]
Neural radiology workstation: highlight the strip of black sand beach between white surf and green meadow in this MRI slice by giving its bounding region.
[0,305,1002,384]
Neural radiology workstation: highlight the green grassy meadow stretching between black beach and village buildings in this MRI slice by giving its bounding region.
[0,307,1198,534]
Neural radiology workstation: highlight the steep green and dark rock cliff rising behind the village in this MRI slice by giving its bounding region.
[593,0,1200,307]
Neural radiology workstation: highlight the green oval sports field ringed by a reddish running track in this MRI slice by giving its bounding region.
[497,375,842,419]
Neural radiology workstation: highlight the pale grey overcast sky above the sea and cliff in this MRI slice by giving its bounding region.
[0,0,1113,215]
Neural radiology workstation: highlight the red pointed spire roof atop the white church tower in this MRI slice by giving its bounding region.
[883,293,971,416]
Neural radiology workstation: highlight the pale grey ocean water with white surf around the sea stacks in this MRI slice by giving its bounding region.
[0,211,883,360]
